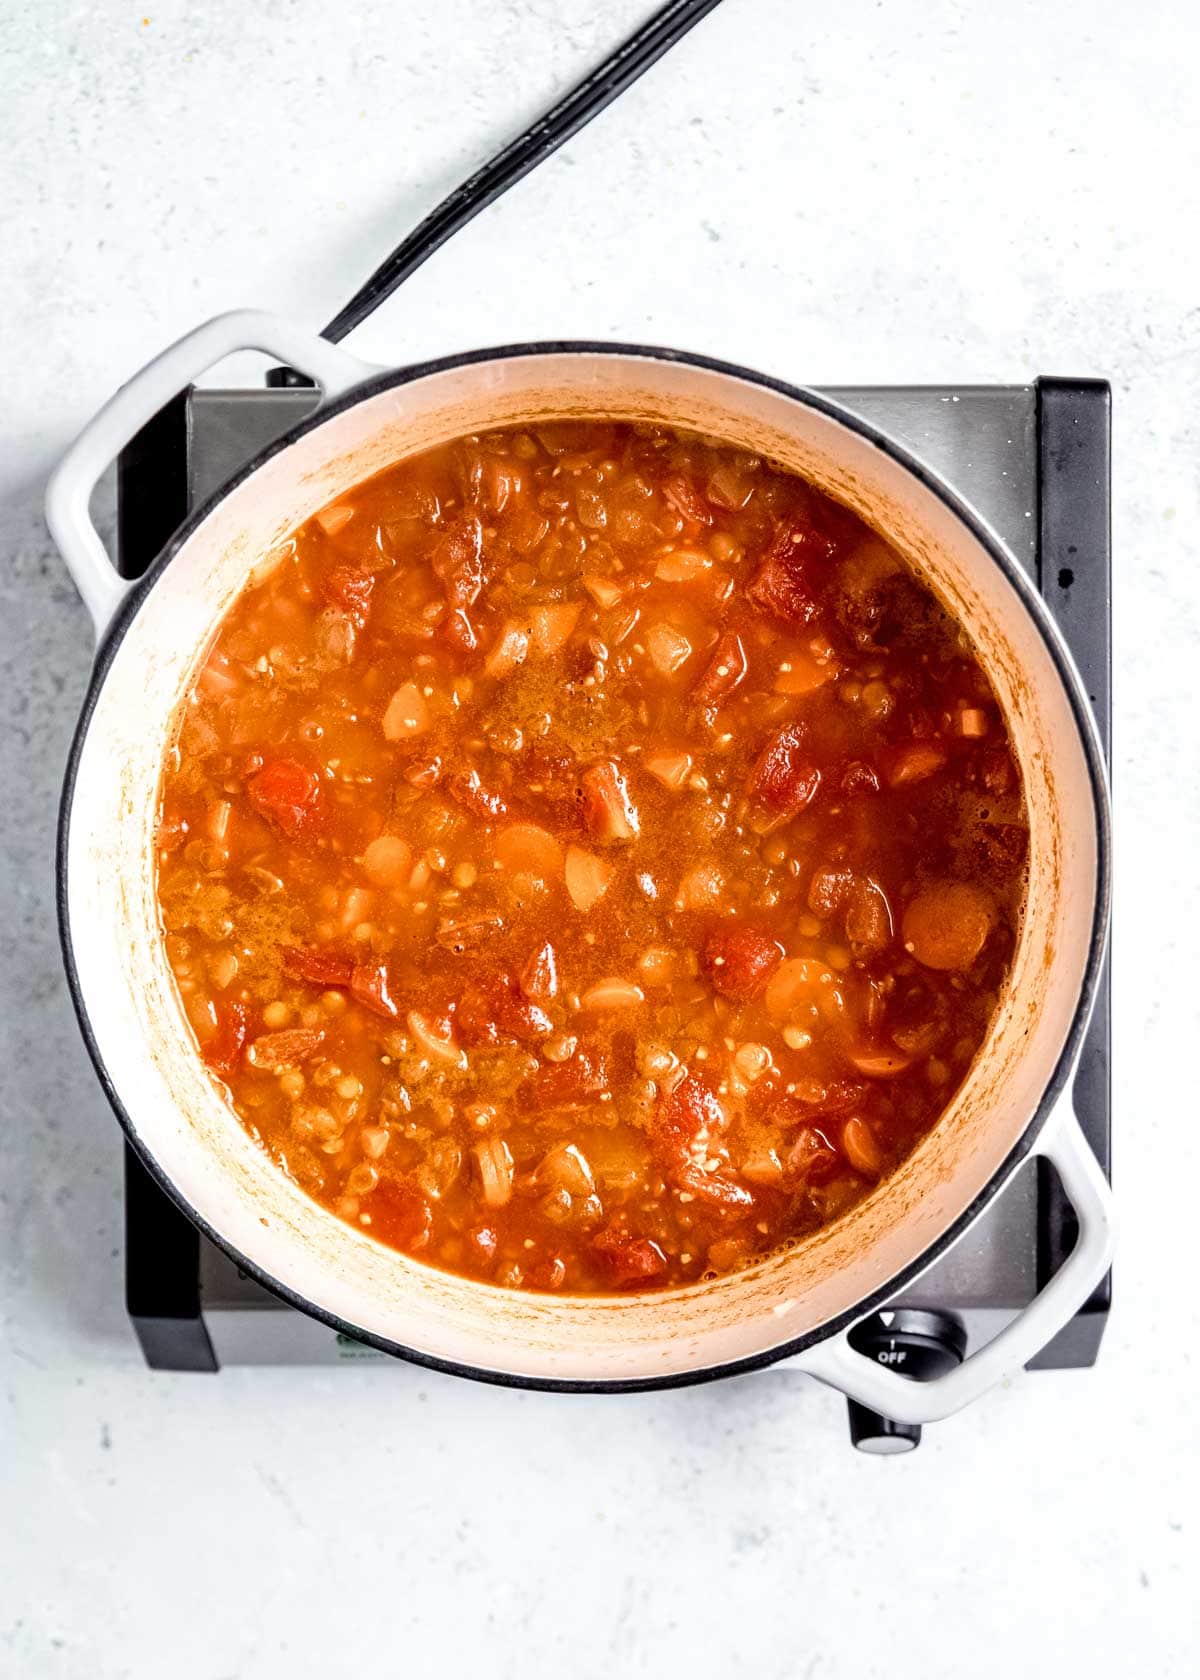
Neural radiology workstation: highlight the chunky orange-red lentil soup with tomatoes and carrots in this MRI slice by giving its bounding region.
[158,420,1027,1292]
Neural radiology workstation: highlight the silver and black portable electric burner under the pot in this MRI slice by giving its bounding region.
[118,378,1111,1452]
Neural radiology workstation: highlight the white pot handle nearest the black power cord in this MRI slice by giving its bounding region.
[45,309,375,642]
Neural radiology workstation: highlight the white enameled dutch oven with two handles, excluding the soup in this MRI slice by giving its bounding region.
[47,311,1111,1423]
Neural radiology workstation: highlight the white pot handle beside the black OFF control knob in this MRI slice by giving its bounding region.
[788,1092,1114,1423]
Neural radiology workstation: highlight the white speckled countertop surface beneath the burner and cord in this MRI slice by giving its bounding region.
[0,0,1200,1680]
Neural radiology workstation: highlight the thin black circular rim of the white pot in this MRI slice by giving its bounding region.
[55,339,1111,1394]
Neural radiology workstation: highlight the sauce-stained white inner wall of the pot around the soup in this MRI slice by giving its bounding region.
[67,351,1097,1381]
